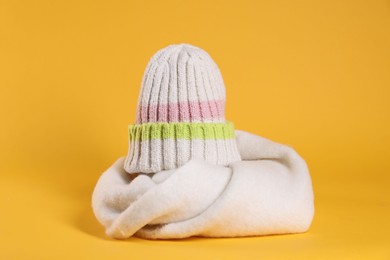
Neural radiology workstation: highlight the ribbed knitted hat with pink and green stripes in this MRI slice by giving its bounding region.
[124,44,241,173]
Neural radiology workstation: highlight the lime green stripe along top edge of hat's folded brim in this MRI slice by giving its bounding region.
[129,122,234,141]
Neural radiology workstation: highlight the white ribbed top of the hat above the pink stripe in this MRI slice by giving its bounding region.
[137,43,226,109]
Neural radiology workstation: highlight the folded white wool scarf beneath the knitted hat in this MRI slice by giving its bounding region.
[92,131,314,239]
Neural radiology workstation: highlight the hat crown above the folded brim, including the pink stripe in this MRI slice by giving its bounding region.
[136,43,226,124]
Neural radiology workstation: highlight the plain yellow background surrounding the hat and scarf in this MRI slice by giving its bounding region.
[0,0,390,259]
